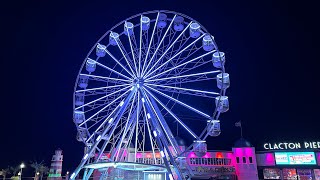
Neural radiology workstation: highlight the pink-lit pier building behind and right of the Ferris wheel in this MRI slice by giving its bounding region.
[93,138,320,180]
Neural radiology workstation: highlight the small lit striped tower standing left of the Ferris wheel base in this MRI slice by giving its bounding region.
[48,149,63,180]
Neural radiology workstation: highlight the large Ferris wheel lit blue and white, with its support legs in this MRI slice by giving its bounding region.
[70,10,230,180]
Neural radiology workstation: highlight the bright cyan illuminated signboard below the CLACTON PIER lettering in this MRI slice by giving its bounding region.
[275,152,317,165]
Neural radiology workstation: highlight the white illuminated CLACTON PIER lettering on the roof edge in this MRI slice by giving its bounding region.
[263,141,320,150]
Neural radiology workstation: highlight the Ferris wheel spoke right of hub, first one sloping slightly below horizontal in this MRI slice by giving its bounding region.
[145,84,220,98]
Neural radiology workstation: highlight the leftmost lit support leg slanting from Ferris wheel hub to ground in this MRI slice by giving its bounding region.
[70,90,136,180]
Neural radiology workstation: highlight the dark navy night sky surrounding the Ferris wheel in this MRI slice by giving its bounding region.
[0,0,320,175]
